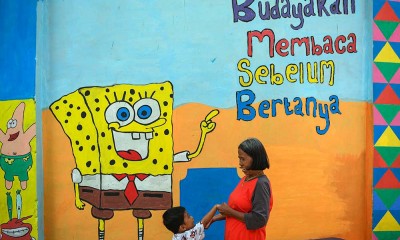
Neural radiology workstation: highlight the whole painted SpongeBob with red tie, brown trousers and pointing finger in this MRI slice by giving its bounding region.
[50,82,219,239]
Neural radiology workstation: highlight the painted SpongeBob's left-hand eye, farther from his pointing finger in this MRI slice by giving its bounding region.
[106,102,135,126]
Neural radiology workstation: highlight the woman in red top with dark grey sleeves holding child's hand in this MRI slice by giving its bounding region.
[207,138,273,240]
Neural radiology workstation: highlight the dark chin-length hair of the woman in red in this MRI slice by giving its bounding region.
[239,138,269,170]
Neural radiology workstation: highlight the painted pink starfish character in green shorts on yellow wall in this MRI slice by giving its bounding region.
[0,102,36,190]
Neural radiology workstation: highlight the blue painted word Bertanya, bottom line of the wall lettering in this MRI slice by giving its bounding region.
[236,89,342,135]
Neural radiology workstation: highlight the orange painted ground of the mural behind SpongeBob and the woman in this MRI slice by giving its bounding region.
[43,102,372,240]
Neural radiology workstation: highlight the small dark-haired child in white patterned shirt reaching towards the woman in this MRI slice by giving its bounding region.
[163,205,218,240]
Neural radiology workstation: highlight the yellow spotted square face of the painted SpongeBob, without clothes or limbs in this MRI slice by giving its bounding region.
[51,82,173,175]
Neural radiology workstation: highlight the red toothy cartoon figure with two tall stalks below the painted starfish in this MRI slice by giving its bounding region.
[0,190,35,240]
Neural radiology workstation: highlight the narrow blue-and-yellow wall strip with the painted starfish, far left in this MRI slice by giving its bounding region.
[0,1,38,240]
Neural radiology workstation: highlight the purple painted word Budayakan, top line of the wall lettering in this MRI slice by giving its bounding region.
[232,0,356,30]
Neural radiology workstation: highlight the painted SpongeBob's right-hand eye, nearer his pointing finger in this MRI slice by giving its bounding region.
[133,98,160,124]
